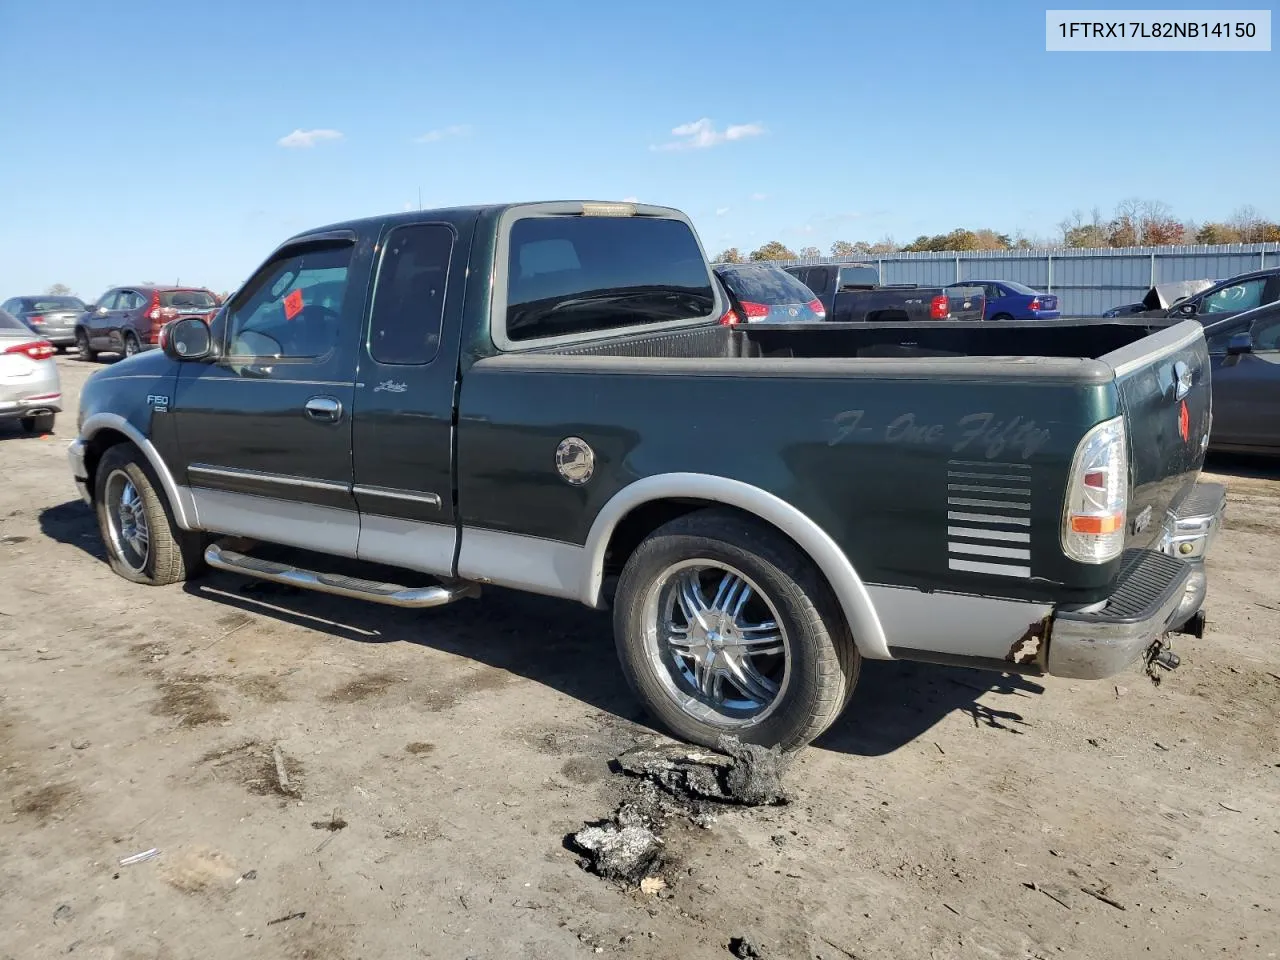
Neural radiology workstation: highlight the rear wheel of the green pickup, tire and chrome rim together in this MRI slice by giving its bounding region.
[613,509,860,750]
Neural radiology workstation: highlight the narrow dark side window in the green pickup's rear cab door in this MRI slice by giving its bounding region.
[369,224,453,364]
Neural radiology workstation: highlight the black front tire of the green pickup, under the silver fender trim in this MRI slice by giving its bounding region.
[93,443,205,586]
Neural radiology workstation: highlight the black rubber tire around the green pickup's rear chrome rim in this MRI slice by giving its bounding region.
[613,508,861,750]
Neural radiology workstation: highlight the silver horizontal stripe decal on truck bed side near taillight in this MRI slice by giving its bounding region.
[947,460,1032,580]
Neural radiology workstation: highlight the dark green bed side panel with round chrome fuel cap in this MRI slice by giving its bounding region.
[458,356,1116,602]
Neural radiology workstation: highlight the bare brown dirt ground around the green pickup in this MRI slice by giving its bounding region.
[0,357,1280,960]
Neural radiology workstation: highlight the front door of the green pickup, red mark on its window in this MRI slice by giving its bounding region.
[168,230,372,557]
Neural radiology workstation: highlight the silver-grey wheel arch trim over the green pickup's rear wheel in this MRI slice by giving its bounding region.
[580,474,892,660]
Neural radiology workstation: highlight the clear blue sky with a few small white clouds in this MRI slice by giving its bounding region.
[0,0,1280,297]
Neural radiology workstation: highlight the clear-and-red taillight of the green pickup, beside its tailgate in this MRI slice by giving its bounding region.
[1062,417,1129,563]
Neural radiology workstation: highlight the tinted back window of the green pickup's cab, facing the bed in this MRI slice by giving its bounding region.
[506,216,716,343]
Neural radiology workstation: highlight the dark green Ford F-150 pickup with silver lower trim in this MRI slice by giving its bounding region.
[69,202,1225,749]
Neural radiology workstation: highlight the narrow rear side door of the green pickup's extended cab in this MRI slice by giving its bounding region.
[352,223,471,576]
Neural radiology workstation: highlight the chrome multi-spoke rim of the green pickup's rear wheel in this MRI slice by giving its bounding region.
[644,559,791,730]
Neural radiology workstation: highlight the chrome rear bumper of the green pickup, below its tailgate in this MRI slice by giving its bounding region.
[1046,484,1226,680]
